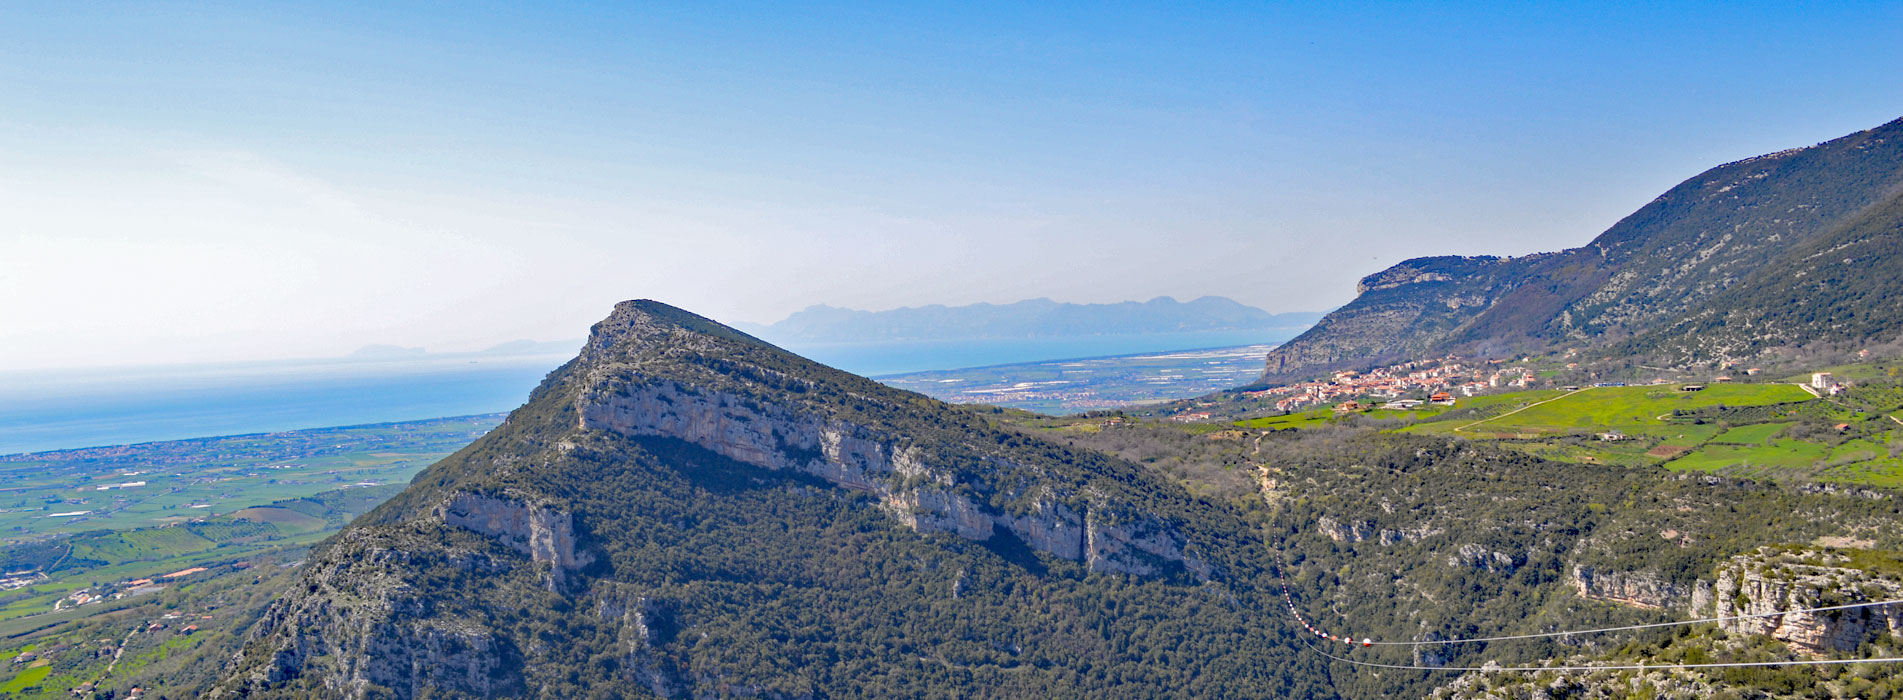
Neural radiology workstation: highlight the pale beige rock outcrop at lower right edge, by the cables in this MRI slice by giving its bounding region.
[1694,550,1903,654]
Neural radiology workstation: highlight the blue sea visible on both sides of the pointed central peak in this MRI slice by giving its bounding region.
[0,331,1286,455]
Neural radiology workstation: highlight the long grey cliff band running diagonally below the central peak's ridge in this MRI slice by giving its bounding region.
[575,380,1210,578]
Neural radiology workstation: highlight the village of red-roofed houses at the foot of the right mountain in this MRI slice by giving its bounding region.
[1248,356,1538,411]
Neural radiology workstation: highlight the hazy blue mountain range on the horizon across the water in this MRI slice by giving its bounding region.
[735,297,1321,344]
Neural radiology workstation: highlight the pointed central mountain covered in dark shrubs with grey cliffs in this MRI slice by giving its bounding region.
[215,302,1334,698]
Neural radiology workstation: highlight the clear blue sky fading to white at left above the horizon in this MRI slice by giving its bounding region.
[0,2,1903,367]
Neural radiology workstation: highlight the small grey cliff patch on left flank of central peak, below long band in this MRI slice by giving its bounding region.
[436,493,588,590]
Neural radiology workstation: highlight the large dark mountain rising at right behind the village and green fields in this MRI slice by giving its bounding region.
[1262,120,1903,384]
